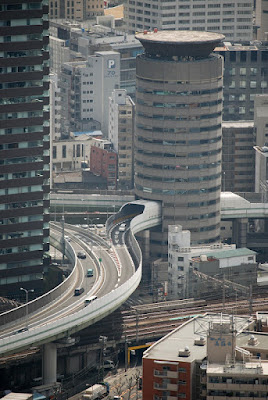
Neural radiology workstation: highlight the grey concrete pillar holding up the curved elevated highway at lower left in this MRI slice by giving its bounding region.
[43,343,57,385]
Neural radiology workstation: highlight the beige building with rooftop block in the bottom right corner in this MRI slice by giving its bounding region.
[205,322,268,400]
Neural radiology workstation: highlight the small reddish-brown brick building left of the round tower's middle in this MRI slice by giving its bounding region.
[90,142,117,189]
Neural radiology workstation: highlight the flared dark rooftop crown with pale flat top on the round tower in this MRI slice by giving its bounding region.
[135,29,224,57]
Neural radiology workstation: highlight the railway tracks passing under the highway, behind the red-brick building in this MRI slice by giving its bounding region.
[0,297,268,364]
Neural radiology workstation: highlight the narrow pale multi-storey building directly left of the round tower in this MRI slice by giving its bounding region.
[108,89,135,189]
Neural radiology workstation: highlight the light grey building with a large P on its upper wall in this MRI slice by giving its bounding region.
[59,51,120,137]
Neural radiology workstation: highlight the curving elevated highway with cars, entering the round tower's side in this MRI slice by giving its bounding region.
[0,201,161,383]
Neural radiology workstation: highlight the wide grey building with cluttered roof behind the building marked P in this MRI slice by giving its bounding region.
[50,20,142,98]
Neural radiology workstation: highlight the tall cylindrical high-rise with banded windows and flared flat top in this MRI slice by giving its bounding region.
[135,30,224,255]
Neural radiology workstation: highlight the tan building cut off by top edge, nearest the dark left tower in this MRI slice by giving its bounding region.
[49,0,104,21]
